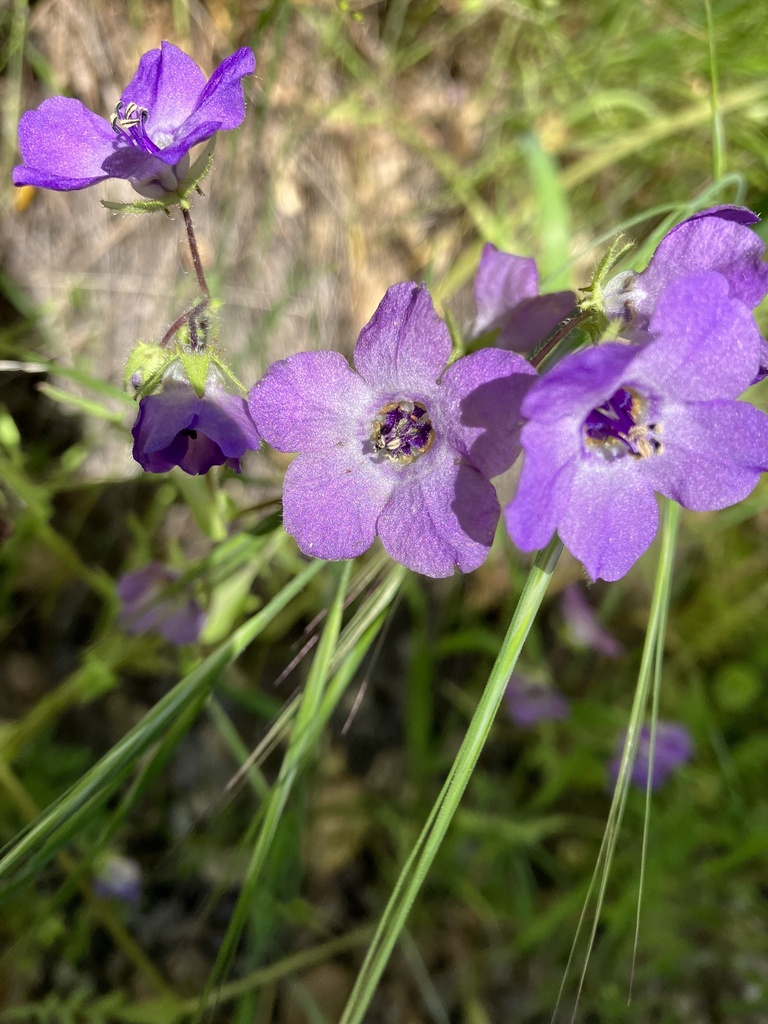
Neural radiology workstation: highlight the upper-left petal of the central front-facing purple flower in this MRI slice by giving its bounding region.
[248,351,378,452]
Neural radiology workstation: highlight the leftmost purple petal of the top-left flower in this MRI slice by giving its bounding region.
[13,96,116,191]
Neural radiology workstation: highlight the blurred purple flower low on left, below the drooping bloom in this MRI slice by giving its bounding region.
[117,562,205,645]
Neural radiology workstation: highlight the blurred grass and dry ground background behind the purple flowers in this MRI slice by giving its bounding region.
[0,0,768,1024]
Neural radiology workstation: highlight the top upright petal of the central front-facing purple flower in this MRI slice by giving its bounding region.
[354,282,452,401]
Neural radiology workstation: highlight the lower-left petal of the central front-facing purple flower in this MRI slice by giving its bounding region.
[283,447,395,559]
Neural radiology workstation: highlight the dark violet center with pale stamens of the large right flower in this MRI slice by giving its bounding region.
[584,387,663,462]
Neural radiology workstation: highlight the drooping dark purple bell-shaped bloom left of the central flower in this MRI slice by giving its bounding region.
[132,362,260,475]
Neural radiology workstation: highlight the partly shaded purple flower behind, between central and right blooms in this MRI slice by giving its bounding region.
[471,243,575,352]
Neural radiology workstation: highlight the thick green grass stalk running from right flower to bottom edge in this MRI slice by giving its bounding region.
[340,540,562,1024]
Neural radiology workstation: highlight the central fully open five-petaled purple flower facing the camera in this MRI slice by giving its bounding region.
[250,283,535,577]
